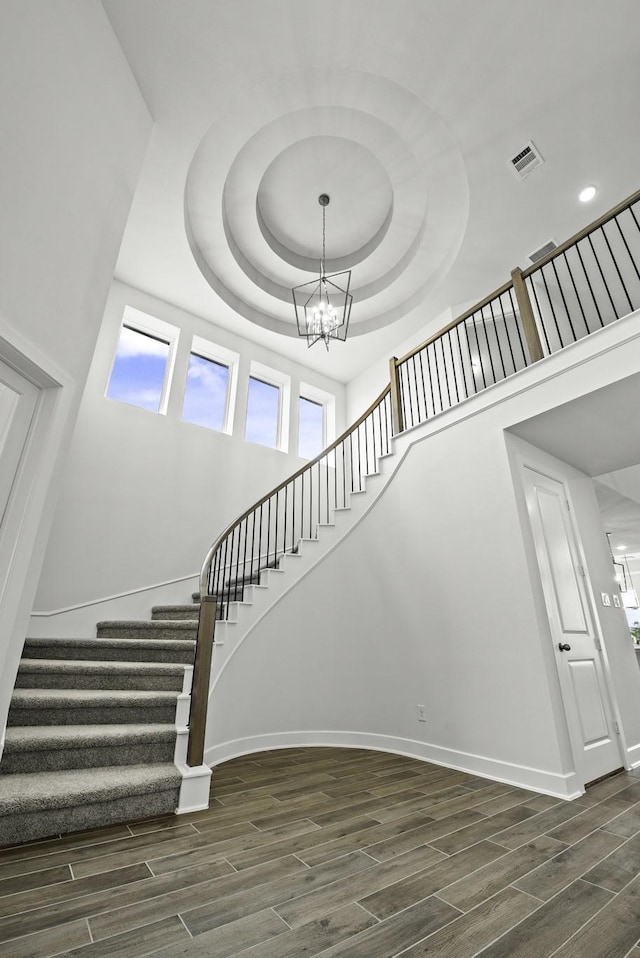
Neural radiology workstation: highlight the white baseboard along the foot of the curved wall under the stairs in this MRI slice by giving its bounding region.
[205,731,584,799]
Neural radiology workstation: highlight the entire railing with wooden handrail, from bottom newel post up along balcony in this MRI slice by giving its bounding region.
[187,191,640,765]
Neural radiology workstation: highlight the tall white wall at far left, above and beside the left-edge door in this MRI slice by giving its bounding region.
[0,0,151,728]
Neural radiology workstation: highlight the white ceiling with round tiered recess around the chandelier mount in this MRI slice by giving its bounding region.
[103,0,640,382]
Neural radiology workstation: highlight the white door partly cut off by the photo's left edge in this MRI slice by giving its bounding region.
[0,360,40,529]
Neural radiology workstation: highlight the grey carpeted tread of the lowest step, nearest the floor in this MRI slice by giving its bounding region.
[0,763,181,825]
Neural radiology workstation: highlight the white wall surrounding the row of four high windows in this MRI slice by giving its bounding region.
[30,282,344,635]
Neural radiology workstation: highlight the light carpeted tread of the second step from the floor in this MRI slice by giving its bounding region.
[4,723,176,757]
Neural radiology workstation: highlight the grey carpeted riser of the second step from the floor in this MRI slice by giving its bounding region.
[0,738,175,775]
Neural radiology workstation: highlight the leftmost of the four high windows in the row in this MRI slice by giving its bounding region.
[106,306,178,413]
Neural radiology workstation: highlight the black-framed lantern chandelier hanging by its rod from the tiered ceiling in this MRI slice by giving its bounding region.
[291,193,353,349]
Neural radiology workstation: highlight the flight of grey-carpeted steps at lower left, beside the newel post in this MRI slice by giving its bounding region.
[0,604,199,846]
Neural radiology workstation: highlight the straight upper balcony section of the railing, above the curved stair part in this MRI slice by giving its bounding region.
[391,191,640,432]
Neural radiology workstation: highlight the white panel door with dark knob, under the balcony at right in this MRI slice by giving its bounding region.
[523,467,623,785]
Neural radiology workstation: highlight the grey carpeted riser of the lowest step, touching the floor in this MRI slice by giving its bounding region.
[0,788,180,846]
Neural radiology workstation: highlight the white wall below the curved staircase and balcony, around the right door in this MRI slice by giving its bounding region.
[207,317,640,796]
